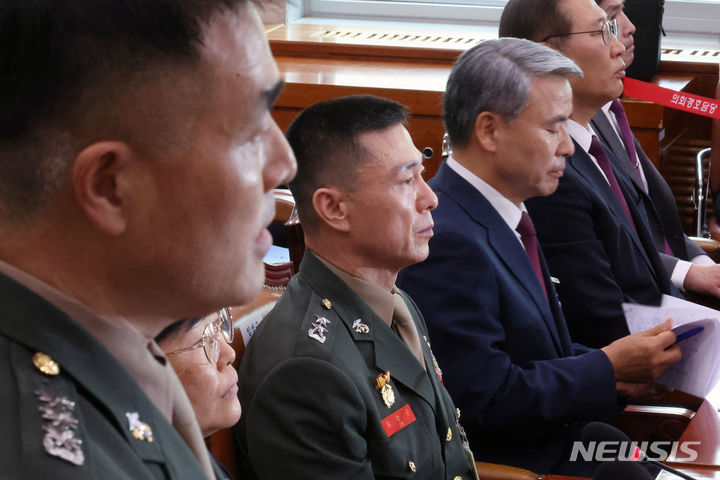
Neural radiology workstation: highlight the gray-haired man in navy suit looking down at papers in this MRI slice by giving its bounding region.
[398,38,680,475]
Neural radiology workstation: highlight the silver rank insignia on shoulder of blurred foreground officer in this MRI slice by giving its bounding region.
[35,389,85,465]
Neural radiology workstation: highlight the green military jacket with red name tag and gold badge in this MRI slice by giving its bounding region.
[236,251,473,480]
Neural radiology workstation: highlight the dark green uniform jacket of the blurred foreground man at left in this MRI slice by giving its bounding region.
[0,275,224,480]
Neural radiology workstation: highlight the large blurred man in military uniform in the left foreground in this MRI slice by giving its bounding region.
[0,0,295,480]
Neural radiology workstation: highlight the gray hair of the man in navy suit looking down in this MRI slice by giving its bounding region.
[443,38,583,147]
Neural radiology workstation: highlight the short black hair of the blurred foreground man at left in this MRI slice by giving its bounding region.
[0,0,254,225]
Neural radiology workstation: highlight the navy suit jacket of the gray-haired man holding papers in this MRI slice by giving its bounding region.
[398,164,619,475]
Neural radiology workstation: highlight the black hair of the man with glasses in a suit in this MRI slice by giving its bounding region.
[498,0,572,50]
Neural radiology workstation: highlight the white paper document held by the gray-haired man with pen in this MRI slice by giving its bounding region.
[623,296,720,398]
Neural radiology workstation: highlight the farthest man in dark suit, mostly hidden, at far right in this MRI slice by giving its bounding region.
[590,0,720,296]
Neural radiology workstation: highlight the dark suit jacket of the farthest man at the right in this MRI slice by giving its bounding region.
[590,110,705,273]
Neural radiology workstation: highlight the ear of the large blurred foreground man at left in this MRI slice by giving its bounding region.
[72,141,132,236]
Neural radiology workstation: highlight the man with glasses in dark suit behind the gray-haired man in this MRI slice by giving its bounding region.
[500,0,681,347]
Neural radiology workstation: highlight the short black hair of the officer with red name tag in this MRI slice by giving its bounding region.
[286,95,408,233]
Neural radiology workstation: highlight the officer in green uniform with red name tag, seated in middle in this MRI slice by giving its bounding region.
[236,96,475,480]
